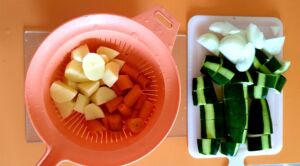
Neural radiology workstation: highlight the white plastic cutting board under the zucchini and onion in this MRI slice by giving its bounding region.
[187,16,283,165]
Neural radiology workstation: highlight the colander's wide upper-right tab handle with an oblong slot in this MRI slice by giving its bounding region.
[133,6,180,50]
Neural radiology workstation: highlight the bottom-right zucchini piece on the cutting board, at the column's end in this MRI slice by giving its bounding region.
[247,134,272,151]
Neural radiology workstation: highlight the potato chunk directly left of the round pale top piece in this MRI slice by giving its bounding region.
[65,60,89,82]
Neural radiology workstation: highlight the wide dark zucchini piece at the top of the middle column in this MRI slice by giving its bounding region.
[224,84,248,100]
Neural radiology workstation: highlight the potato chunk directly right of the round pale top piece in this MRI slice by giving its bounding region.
[102,62,120,87]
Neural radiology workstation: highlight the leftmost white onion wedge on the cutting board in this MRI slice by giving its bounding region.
[197,32,219,55]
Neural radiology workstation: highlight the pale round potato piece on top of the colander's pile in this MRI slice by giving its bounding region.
[82,53,105,81]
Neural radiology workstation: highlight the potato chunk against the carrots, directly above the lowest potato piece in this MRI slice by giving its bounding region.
[90,87,117,105]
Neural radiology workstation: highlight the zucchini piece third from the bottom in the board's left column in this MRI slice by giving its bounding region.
[200,103,224,120]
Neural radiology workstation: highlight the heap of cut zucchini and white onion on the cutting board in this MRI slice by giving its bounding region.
[192,22,290,156]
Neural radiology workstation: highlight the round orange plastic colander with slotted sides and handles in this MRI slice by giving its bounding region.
[25,7,180,166]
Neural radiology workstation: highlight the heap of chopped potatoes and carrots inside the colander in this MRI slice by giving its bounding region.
[50,44,154,134]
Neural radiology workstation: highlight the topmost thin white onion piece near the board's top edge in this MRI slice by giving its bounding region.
[209,22,240,36]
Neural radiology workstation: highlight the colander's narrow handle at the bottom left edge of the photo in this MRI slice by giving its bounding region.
[37,148,62,166]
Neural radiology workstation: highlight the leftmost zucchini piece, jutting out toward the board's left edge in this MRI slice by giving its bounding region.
[192,88,217,106]
